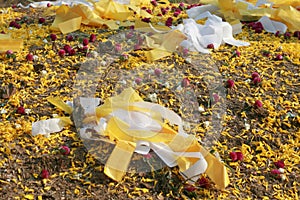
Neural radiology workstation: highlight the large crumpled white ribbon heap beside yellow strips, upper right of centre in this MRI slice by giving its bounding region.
[175,12,250,53]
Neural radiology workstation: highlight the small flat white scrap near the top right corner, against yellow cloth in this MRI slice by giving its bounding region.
[258,16,287,33]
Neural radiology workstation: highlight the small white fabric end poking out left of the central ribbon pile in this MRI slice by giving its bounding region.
[31,118,64,137]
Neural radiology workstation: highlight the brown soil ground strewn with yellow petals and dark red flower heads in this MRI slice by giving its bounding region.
[0,0,300,199]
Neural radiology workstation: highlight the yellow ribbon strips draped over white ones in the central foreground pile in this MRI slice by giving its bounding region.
[96,88,229,189]
